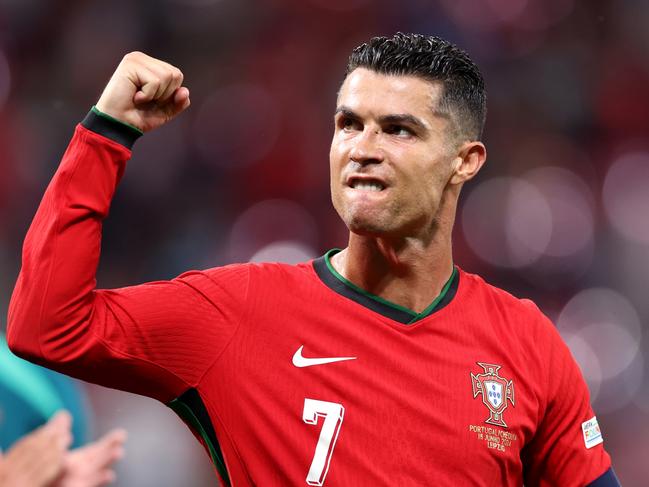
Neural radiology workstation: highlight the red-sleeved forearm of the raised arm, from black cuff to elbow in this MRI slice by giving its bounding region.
[7,114,136,363]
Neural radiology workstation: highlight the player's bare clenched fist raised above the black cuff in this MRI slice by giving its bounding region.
[97,51,190,132]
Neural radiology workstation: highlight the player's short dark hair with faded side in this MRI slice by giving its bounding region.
[345,32,487,140]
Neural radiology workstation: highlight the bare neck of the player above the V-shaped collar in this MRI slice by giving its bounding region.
[331,214,453,313]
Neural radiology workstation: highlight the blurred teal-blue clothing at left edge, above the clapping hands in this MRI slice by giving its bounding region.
[0,334,91,451]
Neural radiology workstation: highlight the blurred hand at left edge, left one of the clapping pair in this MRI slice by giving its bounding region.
[0,411,72,487]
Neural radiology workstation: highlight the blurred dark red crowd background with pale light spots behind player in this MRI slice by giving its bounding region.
[0,0,649,486]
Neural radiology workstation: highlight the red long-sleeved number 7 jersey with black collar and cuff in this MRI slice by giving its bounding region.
[8,114,612,487]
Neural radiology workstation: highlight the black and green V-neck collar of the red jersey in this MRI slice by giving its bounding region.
[313,249,460,325]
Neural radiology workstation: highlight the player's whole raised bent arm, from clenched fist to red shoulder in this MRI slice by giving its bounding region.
[7,52,247,401]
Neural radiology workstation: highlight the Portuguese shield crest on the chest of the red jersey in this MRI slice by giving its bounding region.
[471,362,514,428]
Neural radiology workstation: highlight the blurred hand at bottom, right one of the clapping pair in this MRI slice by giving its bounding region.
[53,429,126,487]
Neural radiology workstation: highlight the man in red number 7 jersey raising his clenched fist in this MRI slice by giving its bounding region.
[9,34,617,486]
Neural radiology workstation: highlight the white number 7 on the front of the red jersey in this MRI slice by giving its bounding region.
[302,398,345,485]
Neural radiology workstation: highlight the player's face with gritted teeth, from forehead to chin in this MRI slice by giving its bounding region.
[329,68,457,237]
